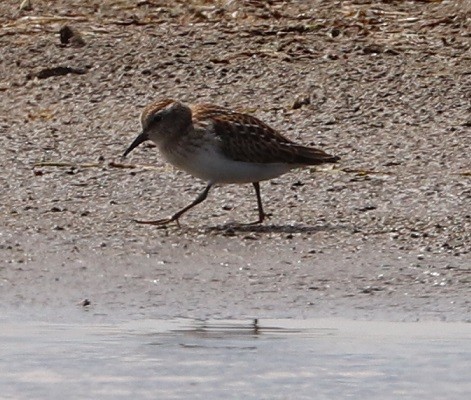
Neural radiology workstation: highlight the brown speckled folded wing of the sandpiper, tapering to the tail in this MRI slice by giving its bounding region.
[193,104,339,165]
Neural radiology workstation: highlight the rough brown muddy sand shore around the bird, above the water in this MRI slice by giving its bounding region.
[0,0,471,321]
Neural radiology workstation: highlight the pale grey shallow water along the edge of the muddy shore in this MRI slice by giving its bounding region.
[0,319,471,400]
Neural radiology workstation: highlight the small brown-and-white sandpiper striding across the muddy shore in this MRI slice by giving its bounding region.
[123,99,339,225]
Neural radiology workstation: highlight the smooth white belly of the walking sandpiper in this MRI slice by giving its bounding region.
[162,148,296,183]
